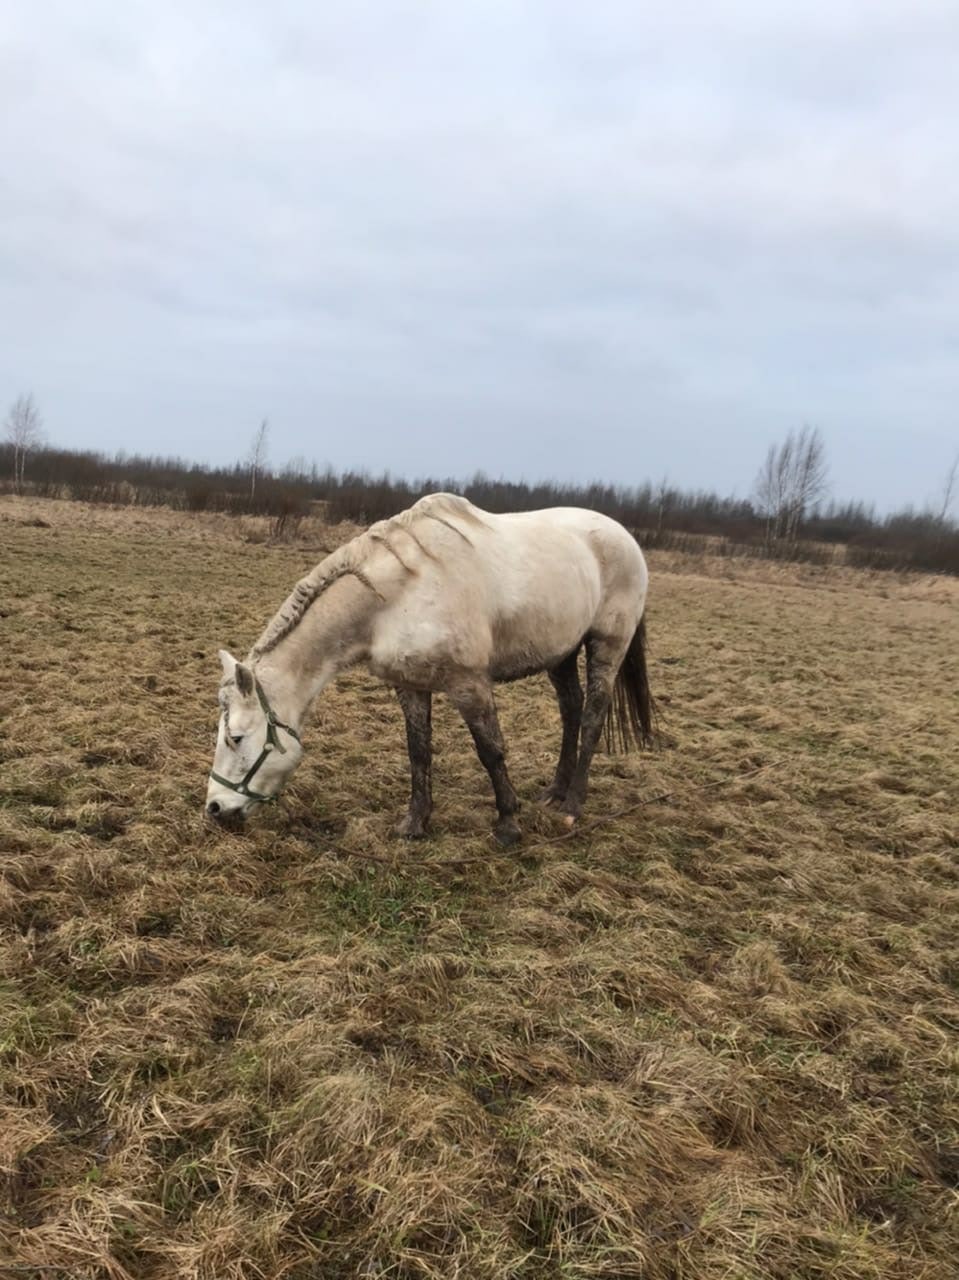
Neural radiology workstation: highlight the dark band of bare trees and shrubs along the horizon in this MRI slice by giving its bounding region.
[0,444,959,573]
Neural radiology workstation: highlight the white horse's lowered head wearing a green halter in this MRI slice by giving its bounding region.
[206,649,303,822]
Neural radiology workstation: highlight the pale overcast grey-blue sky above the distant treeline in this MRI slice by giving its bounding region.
[0,0,959,507]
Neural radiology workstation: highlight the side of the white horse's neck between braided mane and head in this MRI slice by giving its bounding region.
[256,576,380,724]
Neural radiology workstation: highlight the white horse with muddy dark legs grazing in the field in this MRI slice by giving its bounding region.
[206,493,652,845]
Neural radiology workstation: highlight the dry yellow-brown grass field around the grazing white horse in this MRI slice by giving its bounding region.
[0,498,959,1280]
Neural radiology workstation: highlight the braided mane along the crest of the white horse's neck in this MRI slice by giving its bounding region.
[248,493,483,662]
